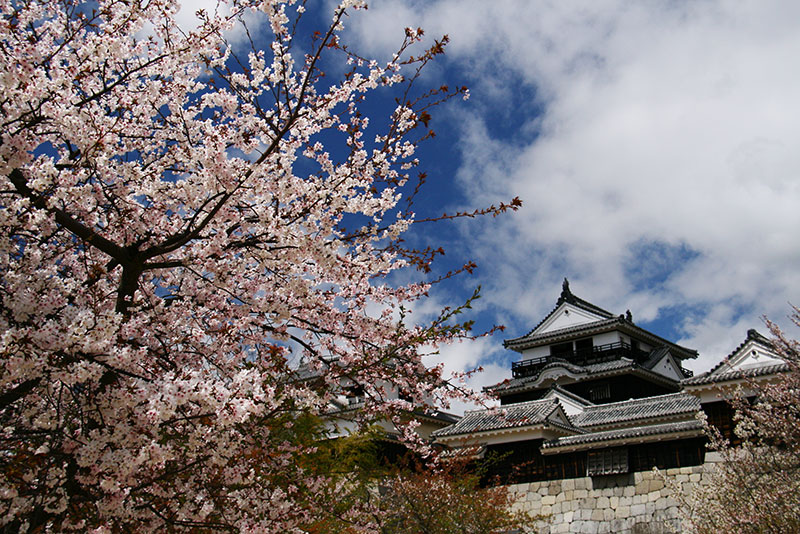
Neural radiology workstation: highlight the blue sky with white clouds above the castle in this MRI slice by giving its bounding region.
[324,0,800,404]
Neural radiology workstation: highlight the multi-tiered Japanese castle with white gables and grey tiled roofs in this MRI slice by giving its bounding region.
[433,279,786,484]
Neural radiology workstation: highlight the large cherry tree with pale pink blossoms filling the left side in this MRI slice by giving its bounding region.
[0,0,518,532]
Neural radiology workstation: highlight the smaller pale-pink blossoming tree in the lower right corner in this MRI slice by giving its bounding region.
[678,308,800,534]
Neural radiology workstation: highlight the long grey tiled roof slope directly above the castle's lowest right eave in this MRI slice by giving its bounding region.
[572,393,700,428]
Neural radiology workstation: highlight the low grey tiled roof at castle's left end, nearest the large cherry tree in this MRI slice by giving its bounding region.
[433,399,559,437]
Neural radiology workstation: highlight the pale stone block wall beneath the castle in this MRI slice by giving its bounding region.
[508,454,717,534]
